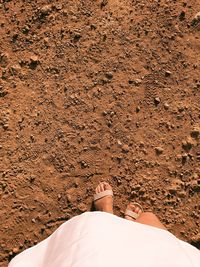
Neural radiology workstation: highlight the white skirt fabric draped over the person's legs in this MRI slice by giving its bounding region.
[9,212,200,267]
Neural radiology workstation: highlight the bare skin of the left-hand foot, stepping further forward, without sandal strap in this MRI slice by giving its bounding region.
[94,182,113,214]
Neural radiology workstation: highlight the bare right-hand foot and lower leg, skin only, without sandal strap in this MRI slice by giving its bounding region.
[125,203,167,230]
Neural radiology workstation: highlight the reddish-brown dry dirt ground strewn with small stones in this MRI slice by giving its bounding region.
[0,0,200,267]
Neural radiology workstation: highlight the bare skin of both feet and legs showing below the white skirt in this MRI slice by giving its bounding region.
[94,182,167,230]
